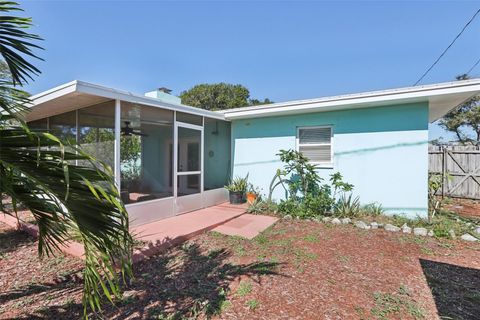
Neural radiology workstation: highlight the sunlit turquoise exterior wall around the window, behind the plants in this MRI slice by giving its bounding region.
[232,102,428,217]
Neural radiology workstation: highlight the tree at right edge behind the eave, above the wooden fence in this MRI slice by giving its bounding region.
[438,74,480,145]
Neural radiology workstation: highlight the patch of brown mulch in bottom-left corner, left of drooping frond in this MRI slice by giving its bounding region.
[0,223,83,319]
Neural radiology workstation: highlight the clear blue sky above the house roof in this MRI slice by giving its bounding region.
[21,0,480,138]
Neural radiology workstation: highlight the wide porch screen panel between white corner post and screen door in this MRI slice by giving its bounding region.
[120,102,173,204]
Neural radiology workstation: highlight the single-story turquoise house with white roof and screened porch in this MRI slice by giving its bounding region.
[26,79,480,225]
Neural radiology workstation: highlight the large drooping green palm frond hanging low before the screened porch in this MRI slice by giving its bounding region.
[0,126,133,311]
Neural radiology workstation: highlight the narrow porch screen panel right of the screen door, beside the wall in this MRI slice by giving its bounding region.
[203,118,231,190]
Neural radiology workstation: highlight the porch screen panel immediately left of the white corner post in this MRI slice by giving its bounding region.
[78,101,115,171]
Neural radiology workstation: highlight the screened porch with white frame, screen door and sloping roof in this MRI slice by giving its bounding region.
[27,81,231,225]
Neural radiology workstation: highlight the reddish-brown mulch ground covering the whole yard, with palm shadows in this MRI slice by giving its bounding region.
[0,220,480,319]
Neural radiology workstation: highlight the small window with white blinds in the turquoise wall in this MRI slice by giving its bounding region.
[297,127,333,165]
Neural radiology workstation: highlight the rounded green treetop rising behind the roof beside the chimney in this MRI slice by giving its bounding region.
[180,82,273,110]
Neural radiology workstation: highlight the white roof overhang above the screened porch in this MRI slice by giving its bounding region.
[25,80,225,121]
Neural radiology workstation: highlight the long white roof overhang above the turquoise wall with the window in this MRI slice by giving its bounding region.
[220,79,480,122]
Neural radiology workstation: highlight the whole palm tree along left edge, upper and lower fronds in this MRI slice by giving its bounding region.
[0,1,133,317]
